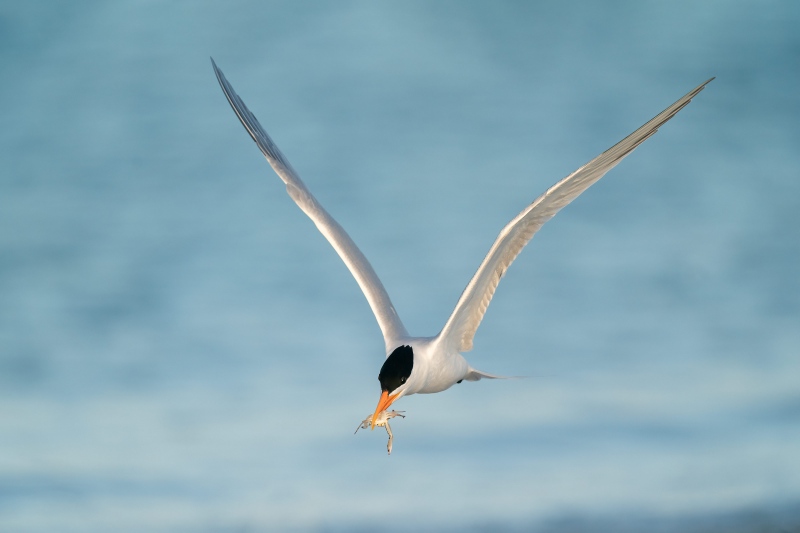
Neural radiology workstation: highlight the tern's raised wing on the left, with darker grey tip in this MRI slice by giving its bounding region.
[211,59,408,353]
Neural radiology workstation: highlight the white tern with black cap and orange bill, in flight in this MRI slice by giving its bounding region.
[211,59,714,436]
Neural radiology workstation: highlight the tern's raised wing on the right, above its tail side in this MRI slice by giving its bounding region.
[439,78,714,352]
